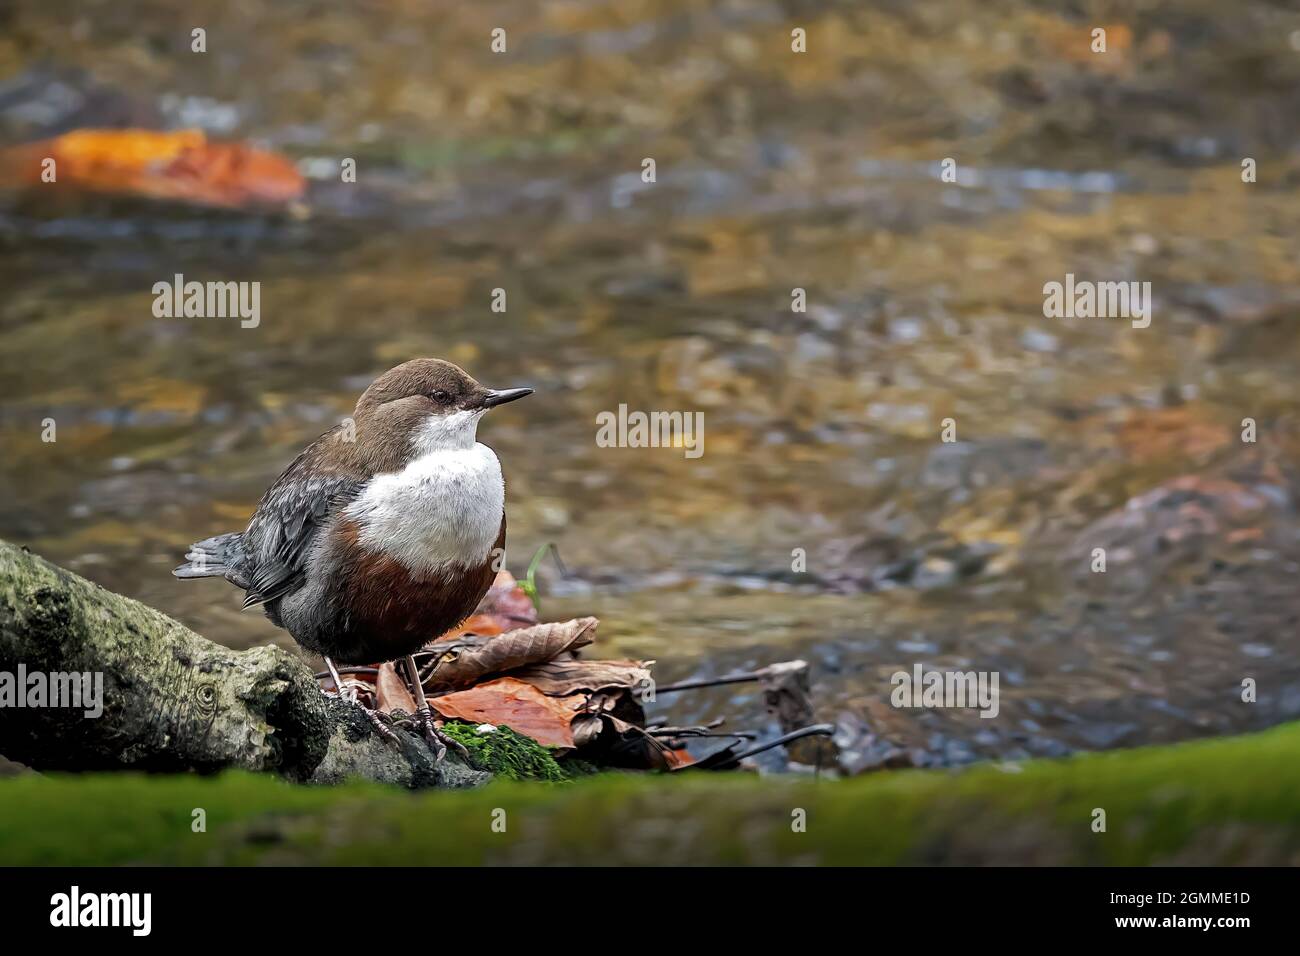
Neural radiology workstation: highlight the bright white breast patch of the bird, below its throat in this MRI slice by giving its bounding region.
[345,444,506,572]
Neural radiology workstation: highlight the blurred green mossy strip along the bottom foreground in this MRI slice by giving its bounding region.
[0,724,1300,865]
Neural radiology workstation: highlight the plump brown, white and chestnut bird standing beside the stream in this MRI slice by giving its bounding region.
[173,359,533,760]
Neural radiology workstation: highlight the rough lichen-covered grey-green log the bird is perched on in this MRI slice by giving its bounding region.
[0,541,490,788]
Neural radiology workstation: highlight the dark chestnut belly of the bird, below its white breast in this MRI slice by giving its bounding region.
[317,555,497,663]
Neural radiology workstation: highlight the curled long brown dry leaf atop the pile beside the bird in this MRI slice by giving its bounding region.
[425,618,599,689]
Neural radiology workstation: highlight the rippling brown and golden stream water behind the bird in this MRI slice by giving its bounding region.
[0,0,1300,773]
